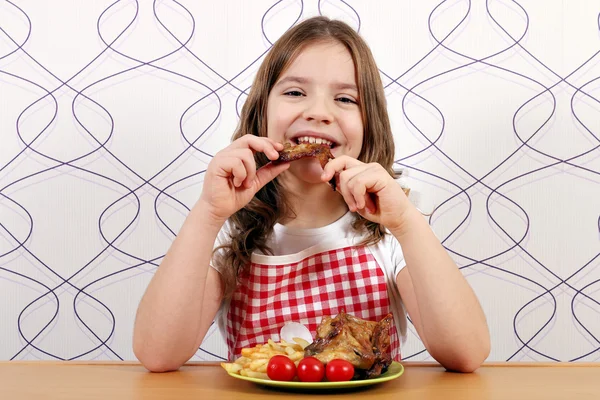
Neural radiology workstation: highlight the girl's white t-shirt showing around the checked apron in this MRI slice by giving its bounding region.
[209,212,407,352]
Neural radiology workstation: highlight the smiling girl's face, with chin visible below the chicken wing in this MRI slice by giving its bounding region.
[267,42,363,183]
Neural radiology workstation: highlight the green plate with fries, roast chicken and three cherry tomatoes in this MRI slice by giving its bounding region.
[221,312,404,389]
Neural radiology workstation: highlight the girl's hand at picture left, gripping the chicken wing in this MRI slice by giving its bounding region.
[200,134,290,224]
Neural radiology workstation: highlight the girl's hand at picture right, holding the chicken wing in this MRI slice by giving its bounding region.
[321,156,410,230]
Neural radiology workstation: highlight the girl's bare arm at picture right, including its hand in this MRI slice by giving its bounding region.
[322,156,490,372]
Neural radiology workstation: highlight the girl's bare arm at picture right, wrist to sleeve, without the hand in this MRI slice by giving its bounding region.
[392,206,490,372]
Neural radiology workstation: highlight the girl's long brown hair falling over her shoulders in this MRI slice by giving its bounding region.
[215,16,394,298]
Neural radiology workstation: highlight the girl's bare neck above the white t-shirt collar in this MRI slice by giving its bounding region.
[279,178,348,228]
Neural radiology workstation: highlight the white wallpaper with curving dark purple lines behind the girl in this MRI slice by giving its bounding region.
[0,0,600,361]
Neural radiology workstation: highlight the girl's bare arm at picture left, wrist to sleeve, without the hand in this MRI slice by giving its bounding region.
[133,202,223,372]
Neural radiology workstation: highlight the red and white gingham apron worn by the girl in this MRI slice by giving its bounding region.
[227,247,400,361]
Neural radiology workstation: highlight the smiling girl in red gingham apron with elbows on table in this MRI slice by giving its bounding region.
[133,17,490,372]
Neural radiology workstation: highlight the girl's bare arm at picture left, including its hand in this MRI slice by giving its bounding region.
[133,135,289,371]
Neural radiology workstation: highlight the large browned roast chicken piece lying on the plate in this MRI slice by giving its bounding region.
[304,312,393,379]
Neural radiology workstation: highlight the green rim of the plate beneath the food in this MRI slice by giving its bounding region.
[228,361,404,389]
